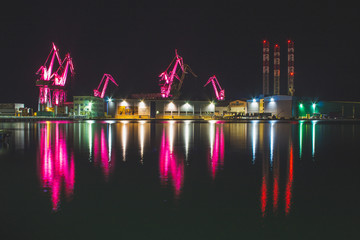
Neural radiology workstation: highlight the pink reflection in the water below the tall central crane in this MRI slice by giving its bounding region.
[159,122,184,198]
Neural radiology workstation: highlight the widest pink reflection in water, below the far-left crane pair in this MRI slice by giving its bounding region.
[37,122,75,211]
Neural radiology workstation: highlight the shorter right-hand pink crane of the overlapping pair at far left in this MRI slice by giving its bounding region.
[52,53,75,106]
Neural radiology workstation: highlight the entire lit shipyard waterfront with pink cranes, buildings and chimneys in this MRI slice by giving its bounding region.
[0,40,348,119]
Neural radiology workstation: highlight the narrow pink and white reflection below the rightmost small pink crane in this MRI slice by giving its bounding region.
[208,123,225,179]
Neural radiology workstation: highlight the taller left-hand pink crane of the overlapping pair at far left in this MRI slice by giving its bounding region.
[36,43,61,110]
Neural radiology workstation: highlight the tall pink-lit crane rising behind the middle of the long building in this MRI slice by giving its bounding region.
[159,49,184,98]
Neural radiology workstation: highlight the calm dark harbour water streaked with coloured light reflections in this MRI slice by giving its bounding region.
[0,121,360,239]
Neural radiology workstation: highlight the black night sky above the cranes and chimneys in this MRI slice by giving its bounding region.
[0,1,360,107]
